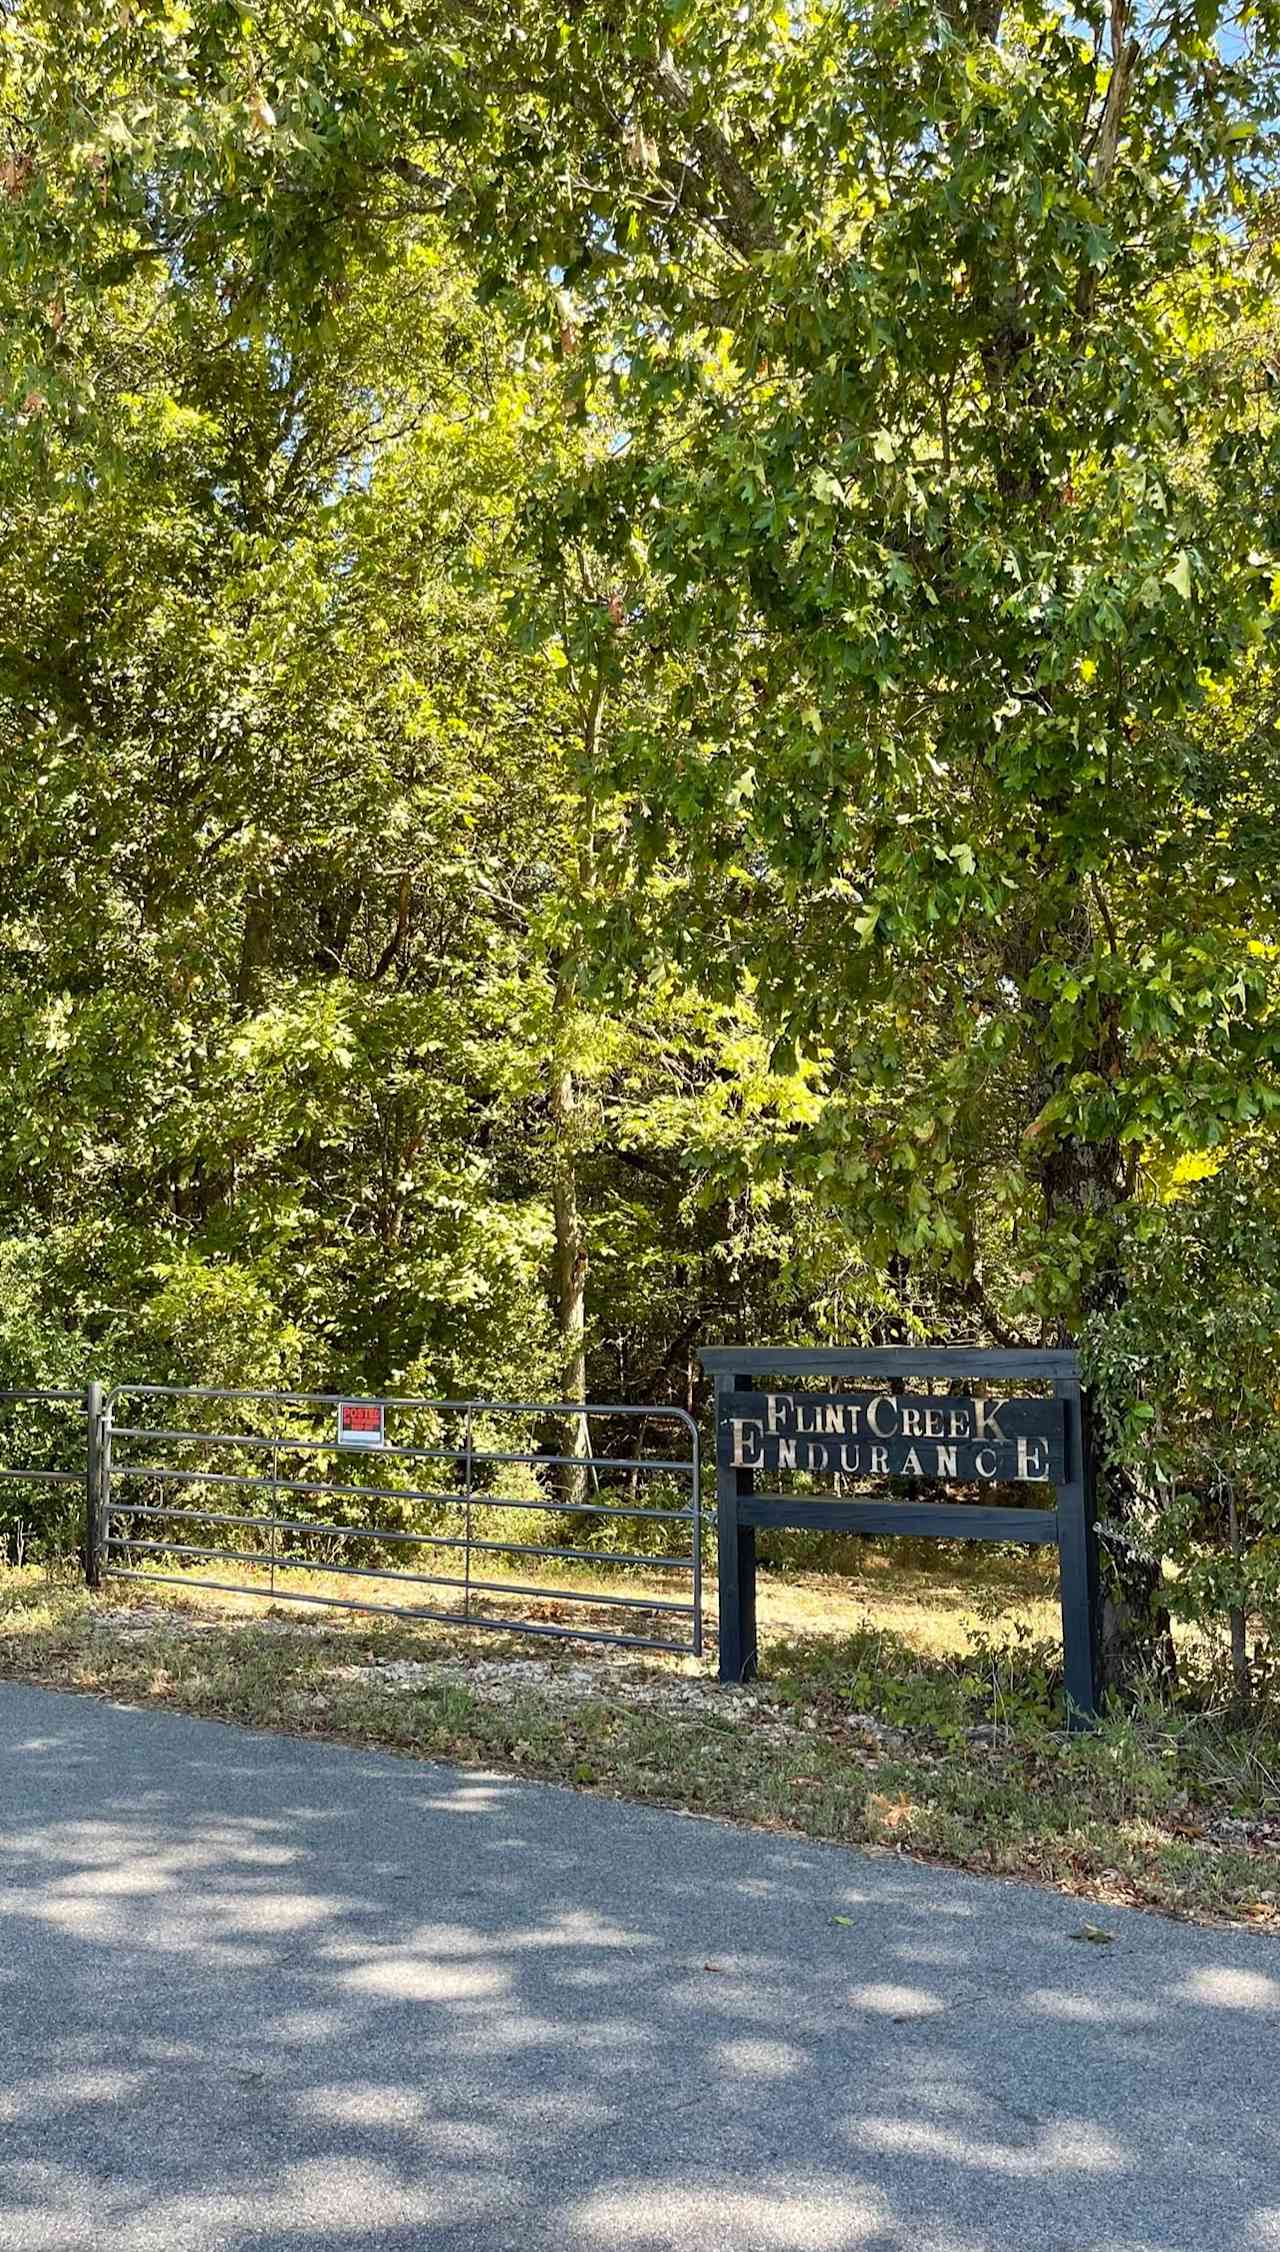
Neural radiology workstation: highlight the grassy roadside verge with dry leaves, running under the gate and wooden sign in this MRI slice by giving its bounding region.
[0,1552,1280,1930]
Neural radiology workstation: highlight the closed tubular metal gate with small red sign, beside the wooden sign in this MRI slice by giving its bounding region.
[86,1385,703,1655]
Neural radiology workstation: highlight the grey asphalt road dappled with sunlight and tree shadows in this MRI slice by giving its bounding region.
[0,1687,1280,2252]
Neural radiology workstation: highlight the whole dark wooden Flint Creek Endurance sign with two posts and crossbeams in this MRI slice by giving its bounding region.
[701,1344,1100,1727]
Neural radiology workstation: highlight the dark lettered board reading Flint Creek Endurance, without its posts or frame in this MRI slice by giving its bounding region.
[719,1392,1066,1484]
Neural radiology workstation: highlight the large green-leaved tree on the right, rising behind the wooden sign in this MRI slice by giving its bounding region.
[482,7,1278,1666]
